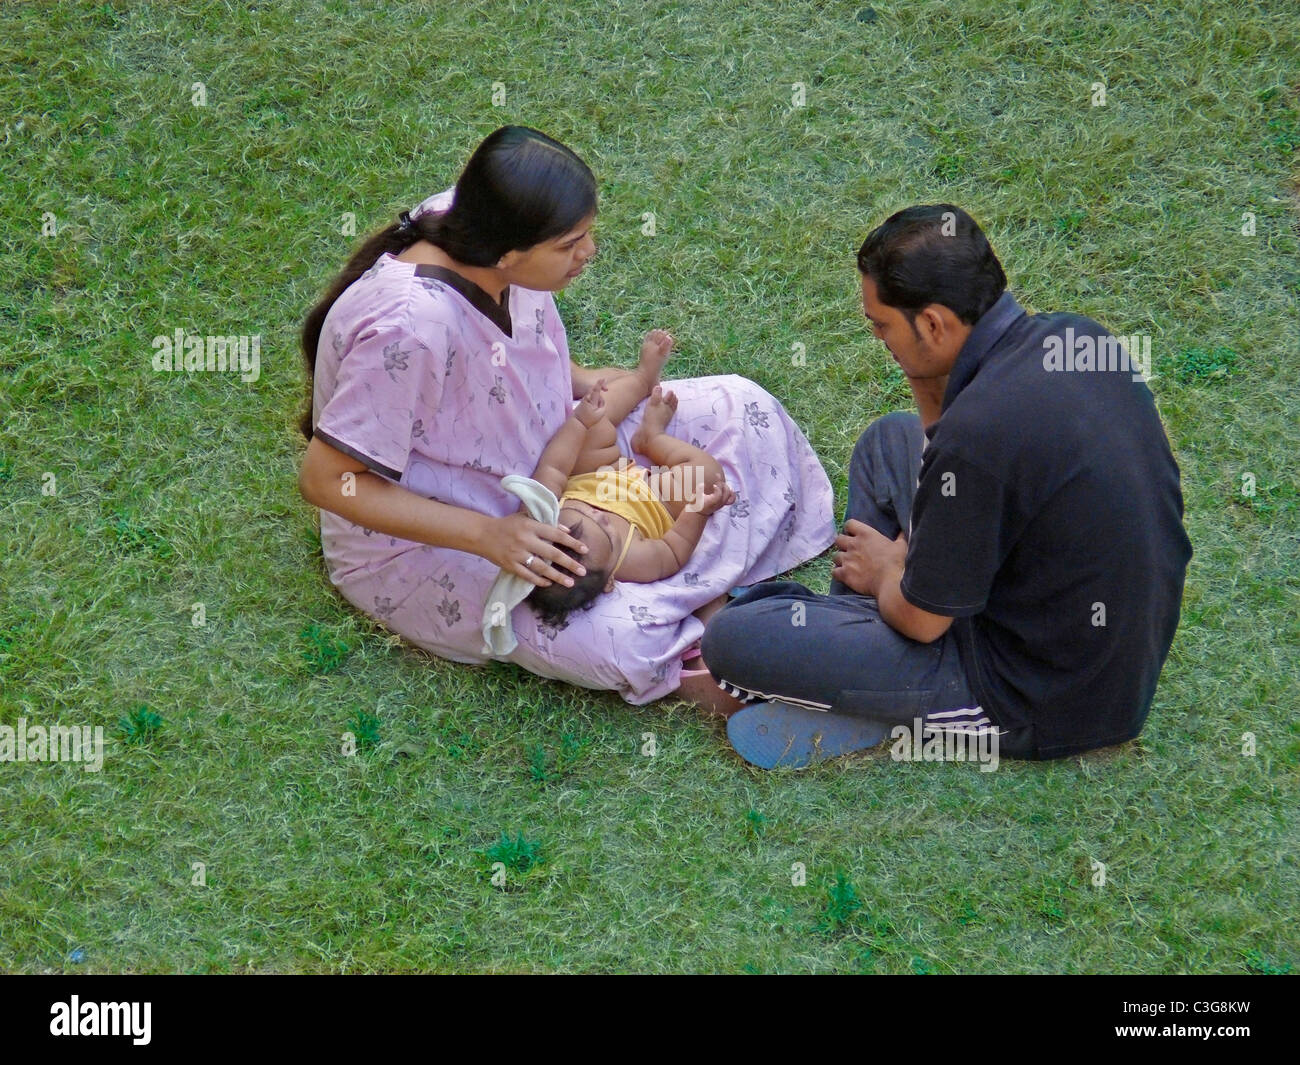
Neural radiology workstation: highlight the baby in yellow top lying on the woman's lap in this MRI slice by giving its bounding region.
[528,329,736,625]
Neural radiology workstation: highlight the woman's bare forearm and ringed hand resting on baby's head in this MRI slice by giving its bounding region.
[298,437,586,586]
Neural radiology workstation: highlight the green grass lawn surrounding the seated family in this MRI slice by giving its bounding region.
[0,0,1300,974]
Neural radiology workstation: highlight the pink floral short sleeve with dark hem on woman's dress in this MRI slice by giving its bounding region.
[315,316,441,481]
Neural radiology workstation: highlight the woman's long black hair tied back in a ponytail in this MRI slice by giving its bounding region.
[300,126,595,440]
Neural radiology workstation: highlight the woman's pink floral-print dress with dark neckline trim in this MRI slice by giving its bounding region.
[312,195,835,703]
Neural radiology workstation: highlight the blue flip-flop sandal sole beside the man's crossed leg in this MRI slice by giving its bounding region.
[727,701,889,769]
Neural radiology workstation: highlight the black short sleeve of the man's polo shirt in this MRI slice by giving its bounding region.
[901,442,1013,618]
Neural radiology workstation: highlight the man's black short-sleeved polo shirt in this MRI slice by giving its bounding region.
[902,293,1192,758]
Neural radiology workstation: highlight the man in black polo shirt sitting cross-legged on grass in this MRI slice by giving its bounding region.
[702,204,1192,769]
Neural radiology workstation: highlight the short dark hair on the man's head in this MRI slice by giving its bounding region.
[858,203,1006,330]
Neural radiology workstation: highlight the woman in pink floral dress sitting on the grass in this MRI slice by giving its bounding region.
[299,126,833,705]
